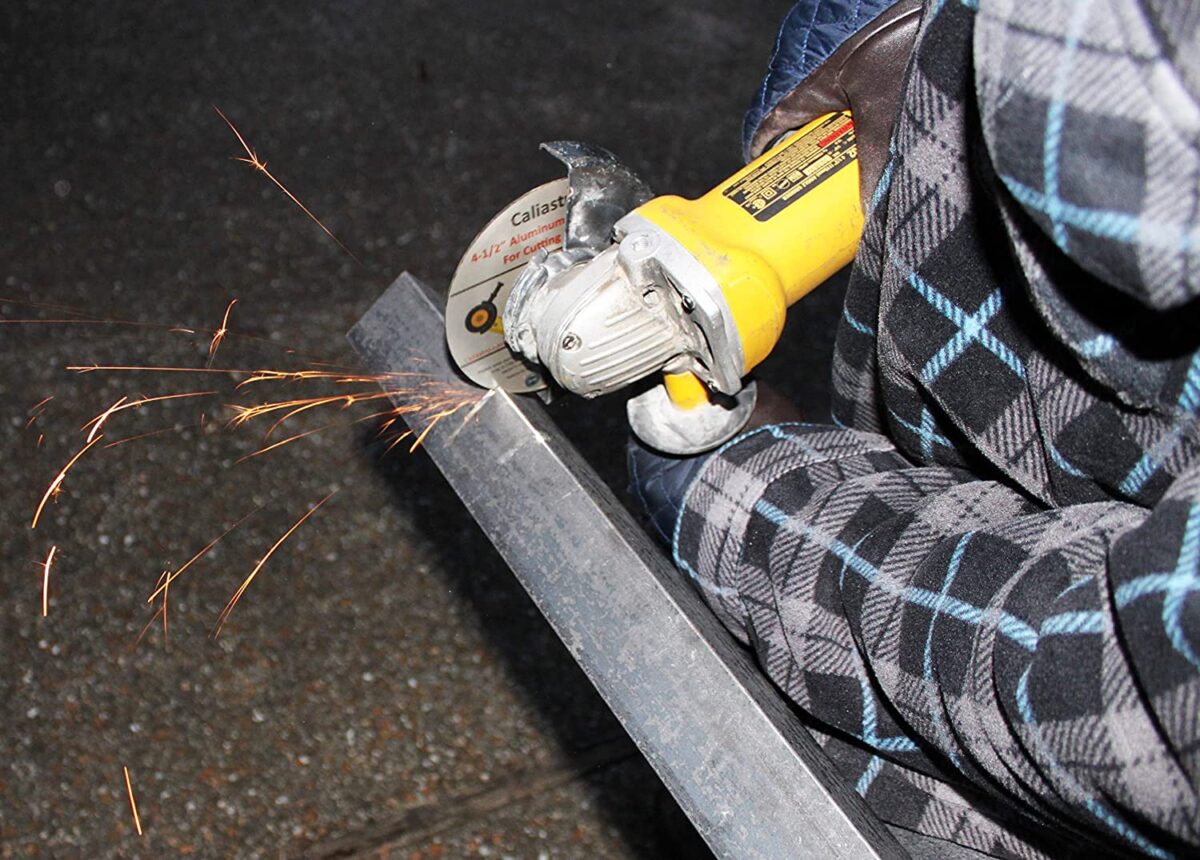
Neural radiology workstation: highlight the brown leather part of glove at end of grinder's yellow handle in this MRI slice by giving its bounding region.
[750,0,922,212]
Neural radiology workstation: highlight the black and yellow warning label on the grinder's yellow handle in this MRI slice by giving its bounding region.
[721,114,858,221]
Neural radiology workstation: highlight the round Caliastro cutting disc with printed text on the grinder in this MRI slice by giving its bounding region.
[446,178,570,392]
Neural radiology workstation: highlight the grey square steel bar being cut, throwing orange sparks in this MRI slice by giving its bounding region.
[349,273,905,860]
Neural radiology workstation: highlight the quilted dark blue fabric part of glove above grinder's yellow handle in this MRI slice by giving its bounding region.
[742,0,896,161]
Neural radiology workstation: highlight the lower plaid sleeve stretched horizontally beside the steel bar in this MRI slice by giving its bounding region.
[674,425,1200,856]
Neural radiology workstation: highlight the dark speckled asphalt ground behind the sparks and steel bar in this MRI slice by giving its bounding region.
[0,0,836,858]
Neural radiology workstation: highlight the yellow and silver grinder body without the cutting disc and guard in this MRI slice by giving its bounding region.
[504,113,863,453]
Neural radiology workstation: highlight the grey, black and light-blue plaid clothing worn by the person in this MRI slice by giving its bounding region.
[673,0,1200,856]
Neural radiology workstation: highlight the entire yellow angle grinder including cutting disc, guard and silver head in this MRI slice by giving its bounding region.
[445,113,863,455]
